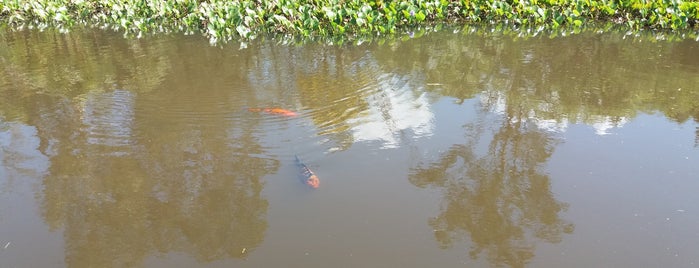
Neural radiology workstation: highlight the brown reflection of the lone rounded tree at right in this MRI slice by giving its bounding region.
[410,110,574,267]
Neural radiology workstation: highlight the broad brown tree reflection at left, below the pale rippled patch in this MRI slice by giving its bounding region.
[35,90,278,267]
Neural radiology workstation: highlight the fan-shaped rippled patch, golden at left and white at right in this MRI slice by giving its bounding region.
[308,74,434,151]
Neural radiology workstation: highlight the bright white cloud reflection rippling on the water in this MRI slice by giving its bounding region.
[349,74,434,148]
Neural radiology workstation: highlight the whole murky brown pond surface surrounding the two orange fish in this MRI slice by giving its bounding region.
[0,27,699,267]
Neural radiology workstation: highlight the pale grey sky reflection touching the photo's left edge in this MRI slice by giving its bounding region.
[0,122,49,182]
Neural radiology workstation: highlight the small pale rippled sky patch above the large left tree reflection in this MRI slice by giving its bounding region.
[82,90,134,155]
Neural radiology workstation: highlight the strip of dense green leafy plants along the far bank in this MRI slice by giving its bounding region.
[0,0,699,40]
